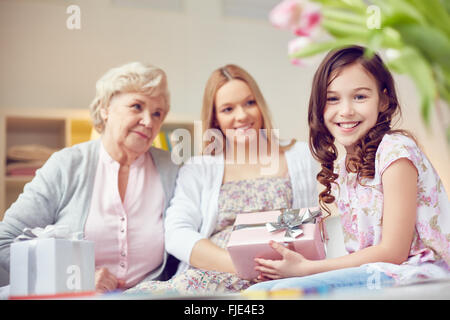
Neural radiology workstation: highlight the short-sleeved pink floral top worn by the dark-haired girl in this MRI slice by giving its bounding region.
[333,134,450,284]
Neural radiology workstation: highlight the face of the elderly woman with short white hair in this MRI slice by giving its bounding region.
[101,93,168,153]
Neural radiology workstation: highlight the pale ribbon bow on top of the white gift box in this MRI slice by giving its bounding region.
[14,225,83,241]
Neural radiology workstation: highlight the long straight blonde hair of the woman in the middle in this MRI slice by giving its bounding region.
[202,64,291,151]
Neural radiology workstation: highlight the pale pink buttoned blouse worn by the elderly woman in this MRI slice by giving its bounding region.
[84,144,164,289]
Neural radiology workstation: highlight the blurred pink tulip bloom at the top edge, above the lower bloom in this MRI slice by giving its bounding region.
[269,0,321,36]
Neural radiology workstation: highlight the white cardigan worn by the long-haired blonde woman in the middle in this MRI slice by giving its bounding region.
[165,142,319,273]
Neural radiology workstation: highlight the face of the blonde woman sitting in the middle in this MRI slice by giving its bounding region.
[215,79,263,146]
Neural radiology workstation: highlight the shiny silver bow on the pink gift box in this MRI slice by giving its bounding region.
[266,209,321,239]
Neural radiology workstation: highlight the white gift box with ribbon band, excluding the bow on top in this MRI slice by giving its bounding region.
[10,238,95,297]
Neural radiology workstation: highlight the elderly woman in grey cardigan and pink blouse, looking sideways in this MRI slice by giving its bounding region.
[0,62,178,292]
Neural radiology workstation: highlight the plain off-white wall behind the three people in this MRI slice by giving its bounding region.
[0,0,450,191]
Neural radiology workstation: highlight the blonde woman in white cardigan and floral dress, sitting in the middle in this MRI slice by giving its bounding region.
[125,65,318,294]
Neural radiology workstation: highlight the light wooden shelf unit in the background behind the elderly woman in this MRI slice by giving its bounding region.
[0,109,194,220]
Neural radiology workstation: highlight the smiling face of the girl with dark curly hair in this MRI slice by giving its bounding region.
[323,63,381,153]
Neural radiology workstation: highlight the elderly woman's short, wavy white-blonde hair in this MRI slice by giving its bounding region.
[89,62,170,133]
